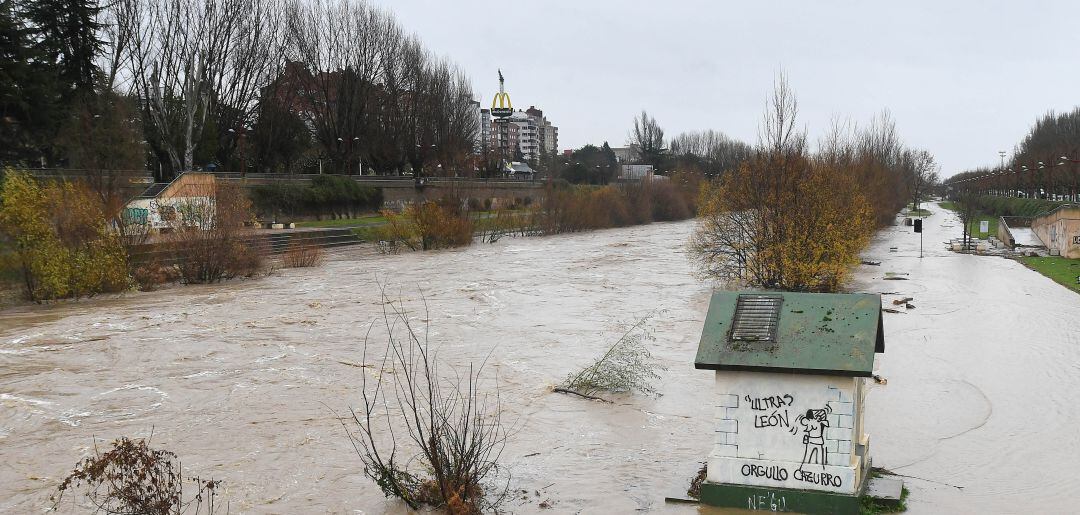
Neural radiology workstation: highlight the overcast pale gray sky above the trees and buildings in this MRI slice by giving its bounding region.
[374,0,1080,176]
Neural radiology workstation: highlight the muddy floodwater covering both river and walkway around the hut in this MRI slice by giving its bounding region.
[0,207,1080,514]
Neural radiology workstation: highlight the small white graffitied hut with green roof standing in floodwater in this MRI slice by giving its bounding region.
[694,292,885,514]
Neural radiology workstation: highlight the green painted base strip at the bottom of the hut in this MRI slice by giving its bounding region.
[701,482,859,515]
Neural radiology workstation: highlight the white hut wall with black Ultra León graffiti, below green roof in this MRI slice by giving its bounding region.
[707,371,866,493]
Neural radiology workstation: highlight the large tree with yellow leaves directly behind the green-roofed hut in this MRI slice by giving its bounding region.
[690,78,875,292]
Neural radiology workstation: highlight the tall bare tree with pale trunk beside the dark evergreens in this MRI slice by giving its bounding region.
[123,0,284,179]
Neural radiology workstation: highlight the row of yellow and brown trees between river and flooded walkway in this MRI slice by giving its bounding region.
[691,77,936,292]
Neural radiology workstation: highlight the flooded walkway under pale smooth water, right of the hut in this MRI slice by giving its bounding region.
[852,202,1080,514]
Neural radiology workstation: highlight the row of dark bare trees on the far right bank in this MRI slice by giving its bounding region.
[947,107,1080,202]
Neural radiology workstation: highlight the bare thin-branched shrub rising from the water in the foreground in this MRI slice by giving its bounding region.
[342,295,509,514]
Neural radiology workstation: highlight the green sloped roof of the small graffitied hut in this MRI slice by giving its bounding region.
[694,292,885,377]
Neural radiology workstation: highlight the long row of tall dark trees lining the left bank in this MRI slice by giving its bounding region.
[0,0,480,180]
